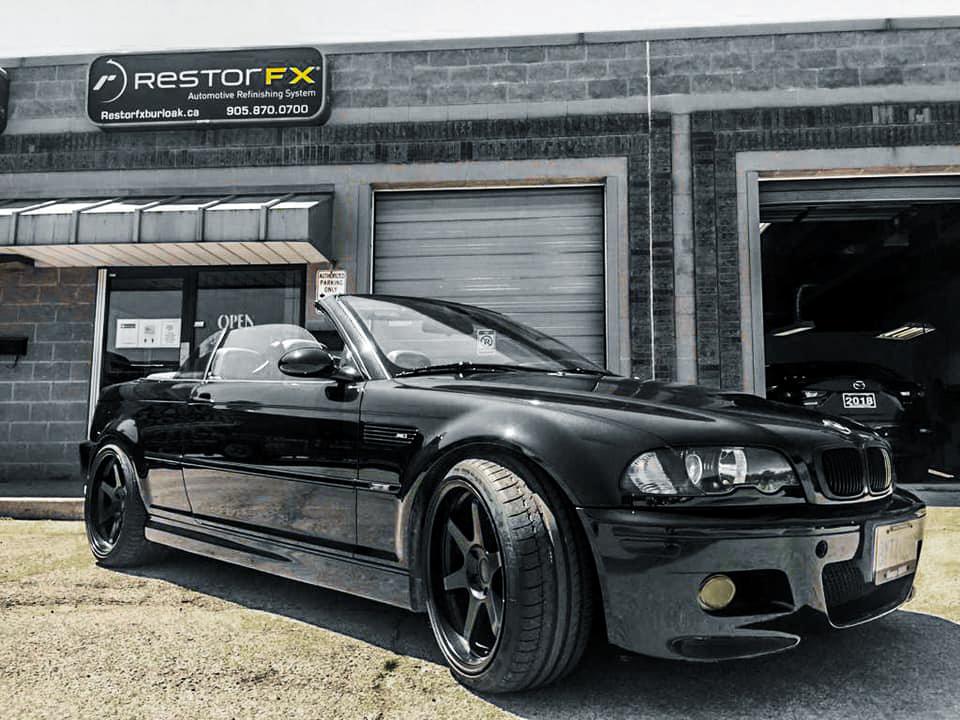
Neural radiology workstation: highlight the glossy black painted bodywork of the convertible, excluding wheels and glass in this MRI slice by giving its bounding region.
[81,297,924,657]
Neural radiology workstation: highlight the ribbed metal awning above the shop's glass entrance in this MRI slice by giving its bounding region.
[0,193,333,267]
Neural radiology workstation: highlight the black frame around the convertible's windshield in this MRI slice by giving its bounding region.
[336,293,614,378]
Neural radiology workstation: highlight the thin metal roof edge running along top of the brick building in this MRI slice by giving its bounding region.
[0,15,960,68]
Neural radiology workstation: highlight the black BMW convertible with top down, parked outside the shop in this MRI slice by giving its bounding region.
[81,295,925,691]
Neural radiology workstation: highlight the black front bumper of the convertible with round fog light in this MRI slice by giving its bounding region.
[579,490,926,660]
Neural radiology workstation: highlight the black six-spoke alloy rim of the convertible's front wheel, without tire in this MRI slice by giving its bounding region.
[431,482,505,672]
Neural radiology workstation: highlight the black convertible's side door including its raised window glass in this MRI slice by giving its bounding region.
[183,324,362,550]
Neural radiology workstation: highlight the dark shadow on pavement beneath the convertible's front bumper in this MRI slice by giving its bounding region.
[496,611,960,720]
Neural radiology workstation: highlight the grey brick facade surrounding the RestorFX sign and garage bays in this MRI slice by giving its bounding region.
[0,18,960,490]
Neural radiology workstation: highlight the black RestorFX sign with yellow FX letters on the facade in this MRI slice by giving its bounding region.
[87,47,329,128]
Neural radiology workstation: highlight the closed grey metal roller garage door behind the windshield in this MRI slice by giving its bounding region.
[373,186,605,363]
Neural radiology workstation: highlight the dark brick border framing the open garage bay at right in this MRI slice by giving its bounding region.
[691,103,960,389]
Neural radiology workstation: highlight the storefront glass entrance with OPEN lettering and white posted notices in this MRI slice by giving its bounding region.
[100,265,306,388]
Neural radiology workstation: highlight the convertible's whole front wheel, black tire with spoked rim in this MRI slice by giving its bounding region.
[422,459,594,693]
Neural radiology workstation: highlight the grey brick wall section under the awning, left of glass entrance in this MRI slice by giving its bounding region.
[0,269,96,494]
